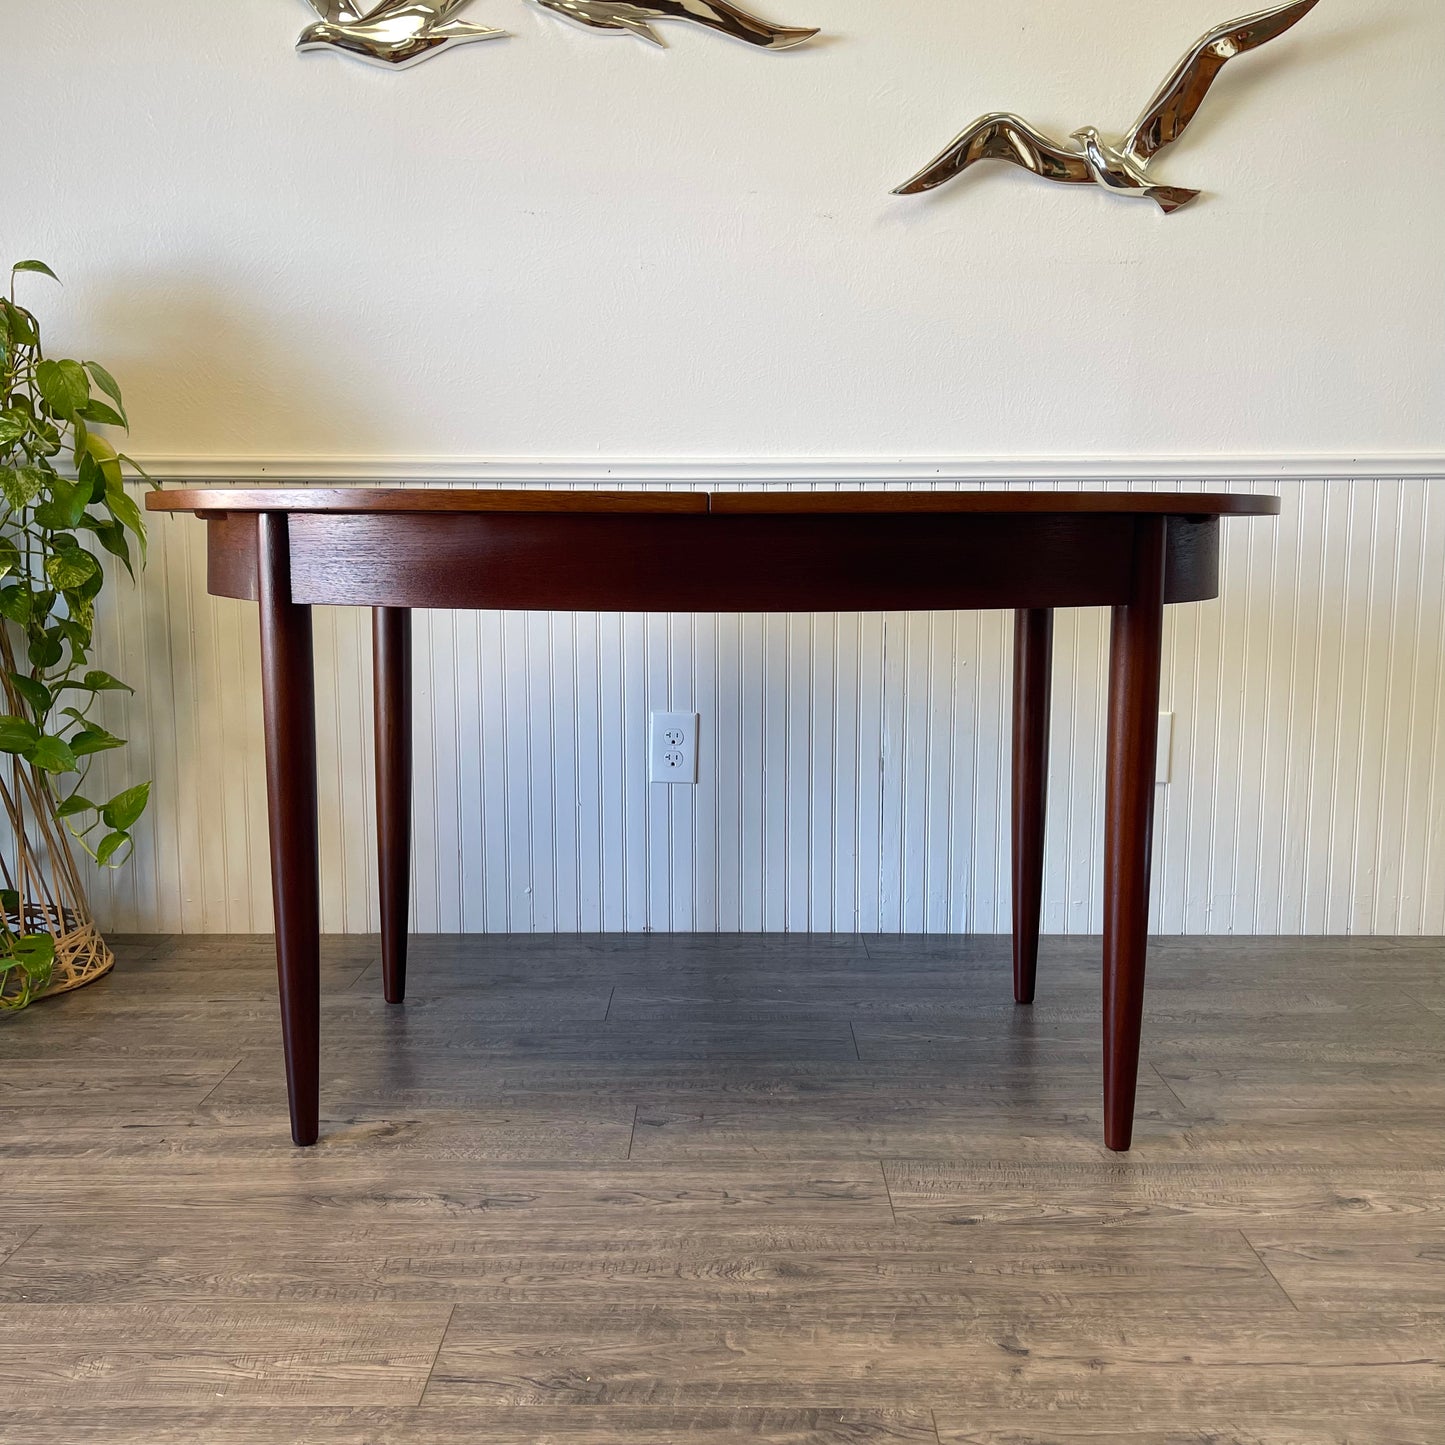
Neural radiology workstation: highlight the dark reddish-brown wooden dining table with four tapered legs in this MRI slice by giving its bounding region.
[146,487,1279,1150]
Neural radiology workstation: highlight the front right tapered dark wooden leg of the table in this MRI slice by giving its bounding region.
[1104,517,1166,1150]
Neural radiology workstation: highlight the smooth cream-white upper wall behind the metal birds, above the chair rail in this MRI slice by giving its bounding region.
[11,0,1445,462]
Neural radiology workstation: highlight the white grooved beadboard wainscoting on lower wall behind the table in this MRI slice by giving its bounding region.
[82,476,1445,933]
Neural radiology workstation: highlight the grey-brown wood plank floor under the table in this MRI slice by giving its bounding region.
[0,935,1445,1445]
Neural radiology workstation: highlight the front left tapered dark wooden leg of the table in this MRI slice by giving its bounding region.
[256,512,321,1144]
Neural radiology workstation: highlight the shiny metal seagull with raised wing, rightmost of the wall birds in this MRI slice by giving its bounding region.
[893,0,1319,215]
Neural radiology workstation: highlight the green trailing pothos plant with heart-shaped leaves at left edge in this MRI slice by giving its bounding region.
[0,262,155,1007]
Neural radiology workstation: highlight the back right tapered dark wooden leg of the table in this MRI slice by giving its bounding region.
[1013,607,1053,1003]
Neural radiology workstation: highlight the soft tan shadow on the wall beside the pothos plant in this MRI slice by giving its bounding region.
[88,273,387,458]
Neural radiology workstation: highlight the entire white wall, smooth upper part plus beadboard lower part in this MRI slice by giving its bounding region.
[11,0,1445,932]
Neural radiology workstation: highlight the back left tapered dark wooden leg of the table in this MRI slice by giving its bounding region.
[371,607,412,1003]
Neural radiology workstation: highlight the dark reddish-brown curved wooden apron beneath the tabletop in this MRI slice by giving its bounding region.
[205,512,1220,613]
